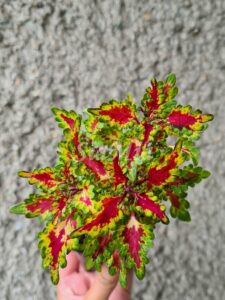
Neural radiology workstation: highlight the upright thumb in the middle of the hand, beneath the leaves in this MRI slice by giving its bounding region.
[84,265,118,300]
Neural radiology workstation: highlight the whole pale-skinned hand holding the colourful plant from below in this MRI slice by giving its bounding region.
[57,252,133,300]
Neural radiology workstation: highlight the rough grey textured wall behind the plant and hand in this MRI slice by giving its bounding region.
[0,0,225,300]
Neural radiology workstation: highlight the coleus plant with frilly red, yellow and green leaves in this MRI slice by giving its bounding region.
[11,74,213,287]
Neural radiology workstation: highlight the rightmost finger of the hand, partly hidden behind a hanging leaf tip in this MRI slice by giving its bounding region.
[109,270,133,300]
